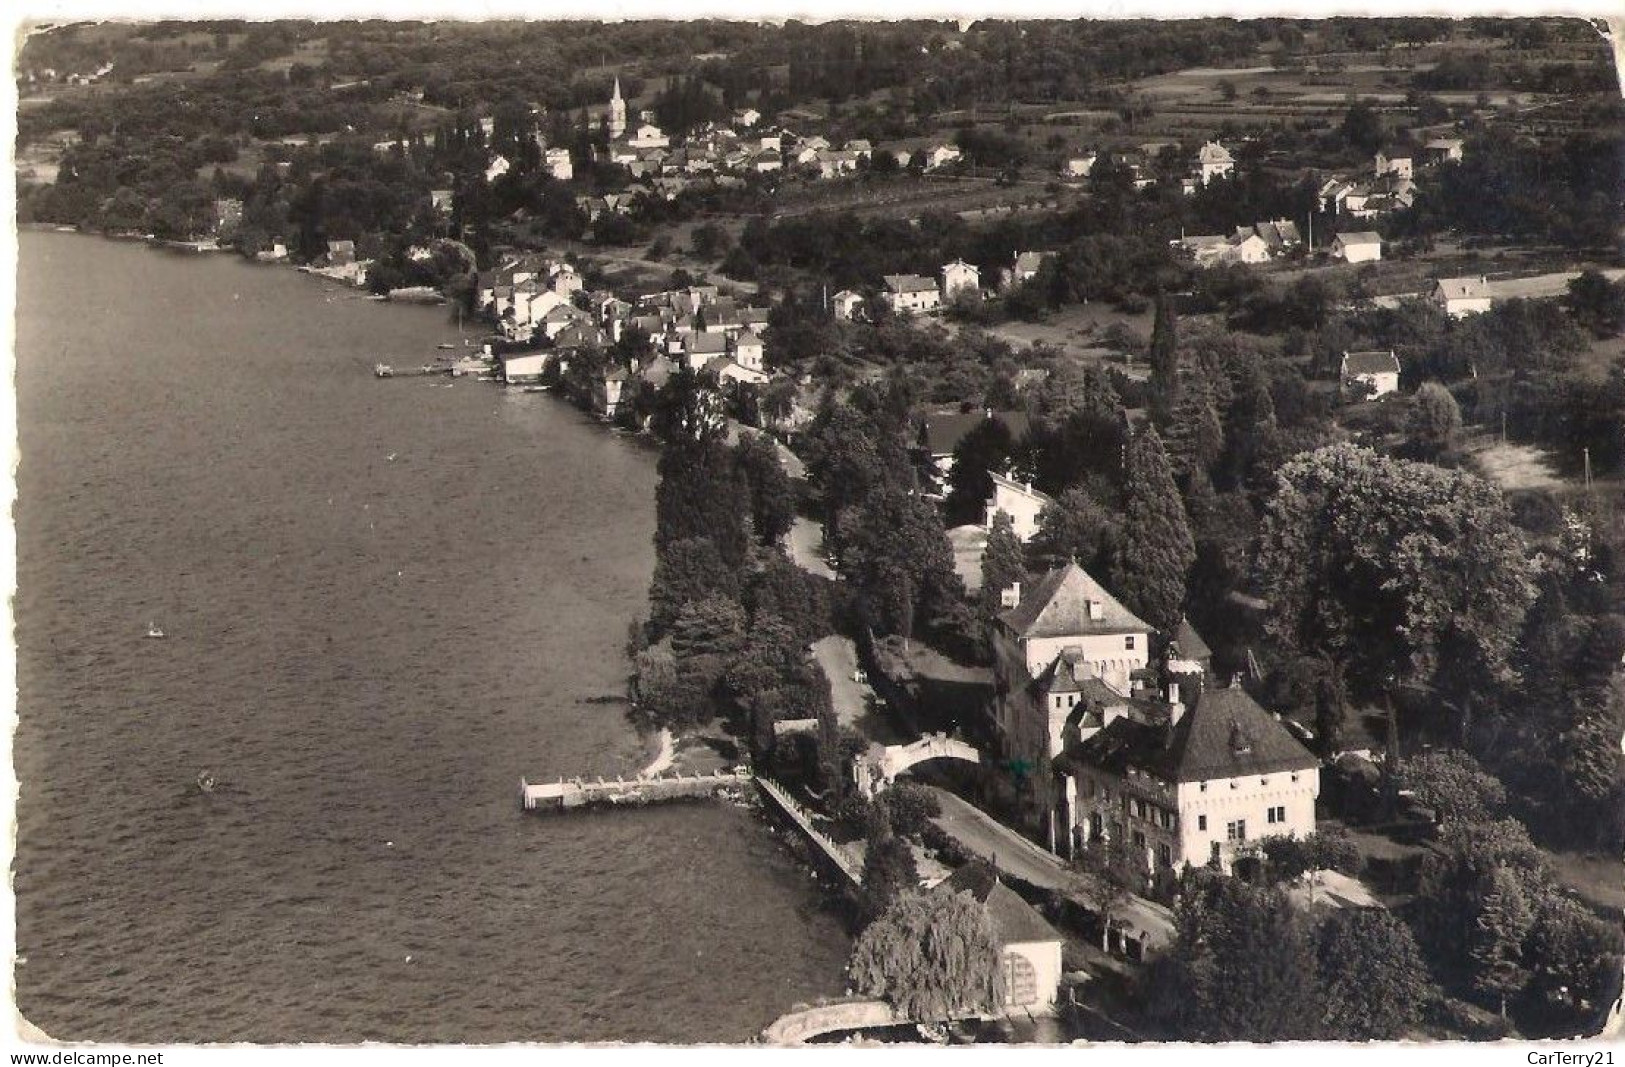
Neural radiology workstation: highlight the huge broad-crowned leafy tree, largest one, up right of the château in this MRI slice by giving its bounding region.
[1256,445,1534,689]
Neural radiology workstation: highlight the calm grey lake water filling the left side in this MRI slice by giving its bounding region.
[15,232,848,1043]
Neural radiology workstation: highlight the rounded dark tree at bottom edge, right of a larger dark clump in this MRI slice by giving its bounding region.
[1315,908,1428,1041]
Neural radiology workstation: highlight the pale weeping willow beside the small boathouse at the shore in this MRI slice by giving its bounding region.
[847,892,1004,1022]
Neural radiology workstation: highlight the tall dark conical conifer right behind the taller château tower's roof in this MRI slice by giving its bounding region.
[1113,427,1196,633]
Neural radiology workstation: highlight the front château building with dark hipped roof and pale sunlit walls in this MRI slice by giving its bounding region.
[1055,679,1320,874]
